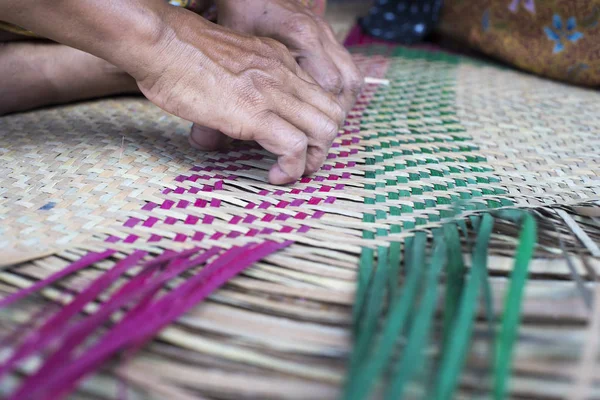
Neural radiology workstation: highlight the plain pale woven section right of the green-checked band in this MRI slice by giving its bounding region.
[456,64,600,205]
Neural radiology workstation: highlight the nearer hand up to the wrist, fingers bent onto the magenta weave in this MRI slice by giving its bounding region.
[133,7,345,184]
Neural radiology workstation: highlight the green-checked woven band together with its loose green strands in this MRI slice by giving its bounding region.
[343,47,529,400]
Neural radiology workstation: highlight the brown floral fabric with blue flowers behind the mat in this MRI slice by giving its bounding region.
[438,0,600,86]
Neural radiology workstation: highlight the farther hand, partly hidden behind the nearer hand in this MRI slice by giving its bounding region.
[190,0,363,155]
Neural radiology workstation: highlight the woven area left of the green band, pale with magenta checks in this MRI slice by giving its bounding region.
[1,54,392,258]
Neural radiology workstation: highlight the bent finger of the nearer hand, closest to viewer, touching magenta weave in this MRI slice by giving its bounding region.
[252,112,308,185]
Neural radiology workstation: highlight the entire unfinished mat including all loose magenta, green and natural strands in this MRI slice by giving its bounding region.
[0,46,600,399]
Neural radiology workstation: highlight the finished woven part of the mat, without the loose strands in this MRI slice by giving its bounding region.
[0,48,600,252]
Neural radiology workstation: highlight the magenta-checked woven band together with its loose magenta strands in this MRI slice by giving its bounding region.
[0,50,398,399]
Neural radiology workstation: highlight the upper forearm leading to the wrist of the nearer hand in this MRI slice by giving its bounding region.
[0,0,172,76]
